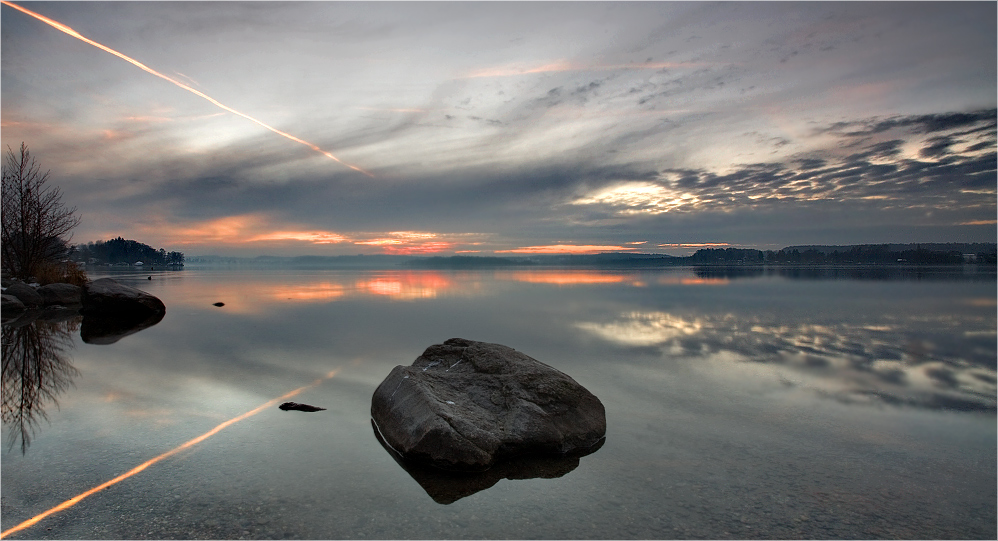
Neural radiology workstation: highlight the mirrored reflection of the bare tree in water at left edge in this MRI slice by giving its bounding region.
[0,311,81,454]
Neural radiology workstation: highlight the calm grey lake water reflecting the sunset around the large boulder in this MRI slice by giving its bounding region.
[0,268,998,539]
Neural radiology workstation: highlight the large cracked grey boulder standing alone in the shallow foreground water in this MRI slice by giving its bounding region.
[371,338,606,470]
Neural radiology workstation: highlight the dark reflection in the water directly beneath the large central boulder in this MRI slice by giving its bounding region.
[371,420,605,505]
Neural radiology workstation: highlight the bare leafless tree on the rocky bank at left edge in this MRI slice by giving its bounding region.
[0,143,80,278]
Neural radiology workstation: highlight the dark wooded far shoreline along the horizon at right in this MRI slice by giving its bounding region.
[682,244,996,265]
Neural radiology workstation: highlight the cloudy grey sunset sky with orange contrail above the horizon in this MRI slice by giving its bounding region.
[0,2,998,256]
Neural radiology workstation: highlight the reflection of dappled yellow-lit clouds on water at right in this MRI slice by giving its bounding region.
[576,311,996,411]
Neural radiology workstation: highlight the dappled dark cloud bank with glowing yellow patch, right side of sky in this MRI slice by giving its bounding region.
[570,110,996,216]
